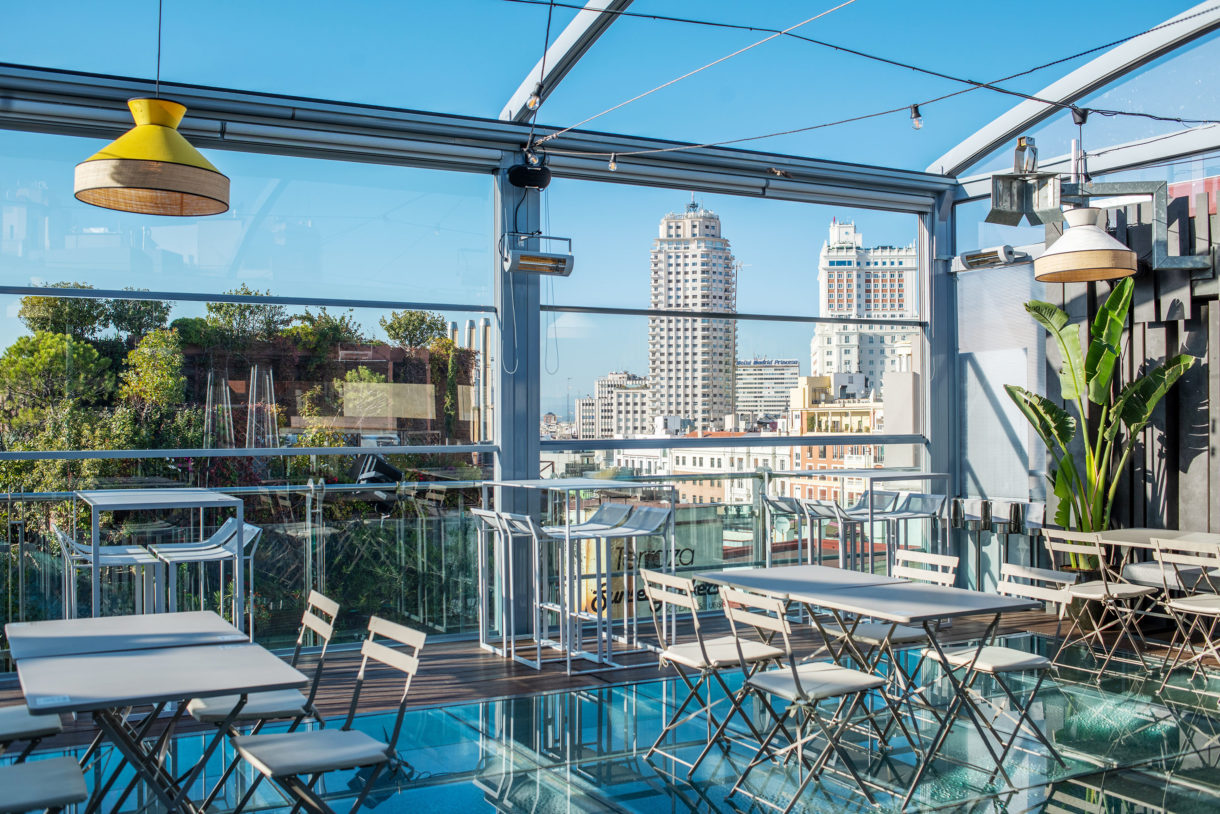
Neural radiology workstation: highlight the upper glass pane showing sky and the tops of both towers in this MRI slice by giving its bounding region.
[543,181,920,317]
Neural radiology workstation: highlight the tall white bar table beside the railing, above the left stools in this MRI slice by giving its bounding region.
[74,488,245,630]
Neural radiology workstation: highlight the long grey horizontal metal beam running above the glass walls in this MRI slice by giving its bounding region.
[0,63,955,212]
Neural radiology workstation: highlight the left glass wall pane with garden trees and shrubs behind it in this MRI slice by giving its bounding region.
[0,295,494,492]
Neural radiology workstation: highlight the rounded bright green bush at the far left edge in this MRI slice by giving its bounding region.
[0,331,115,430]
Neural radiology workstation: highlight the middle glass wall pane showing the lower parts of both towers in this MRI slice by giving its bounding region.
[540,311,925,441]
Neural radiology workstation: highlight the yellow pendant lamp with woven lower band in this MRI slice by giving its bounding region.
[74,99,229,216]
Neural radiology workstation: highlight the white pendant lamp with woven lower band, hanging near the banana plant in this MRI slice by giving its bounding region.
[1033,207,1136,283]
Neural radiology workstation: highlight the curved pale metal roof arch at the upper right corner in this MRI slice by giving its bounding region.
[927,2,1220,176]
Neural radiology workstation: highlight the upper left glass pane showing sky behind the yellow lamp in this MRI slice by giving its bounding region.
[0,131,493,305]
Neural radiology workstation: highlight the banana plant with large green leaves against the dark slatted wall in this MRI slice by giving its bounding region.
[1004,277,1198,531]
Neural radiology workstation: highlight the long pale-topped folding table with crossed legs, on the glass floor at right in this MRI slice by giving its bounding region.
[695,565,1042,807]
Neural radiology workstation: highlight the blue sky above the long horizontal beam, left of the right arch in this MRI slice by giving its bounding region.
[2,0,1194,168]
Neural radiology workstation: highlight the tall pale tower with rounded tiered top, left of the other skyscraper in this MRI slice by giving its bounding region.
[648,200,737,430]
